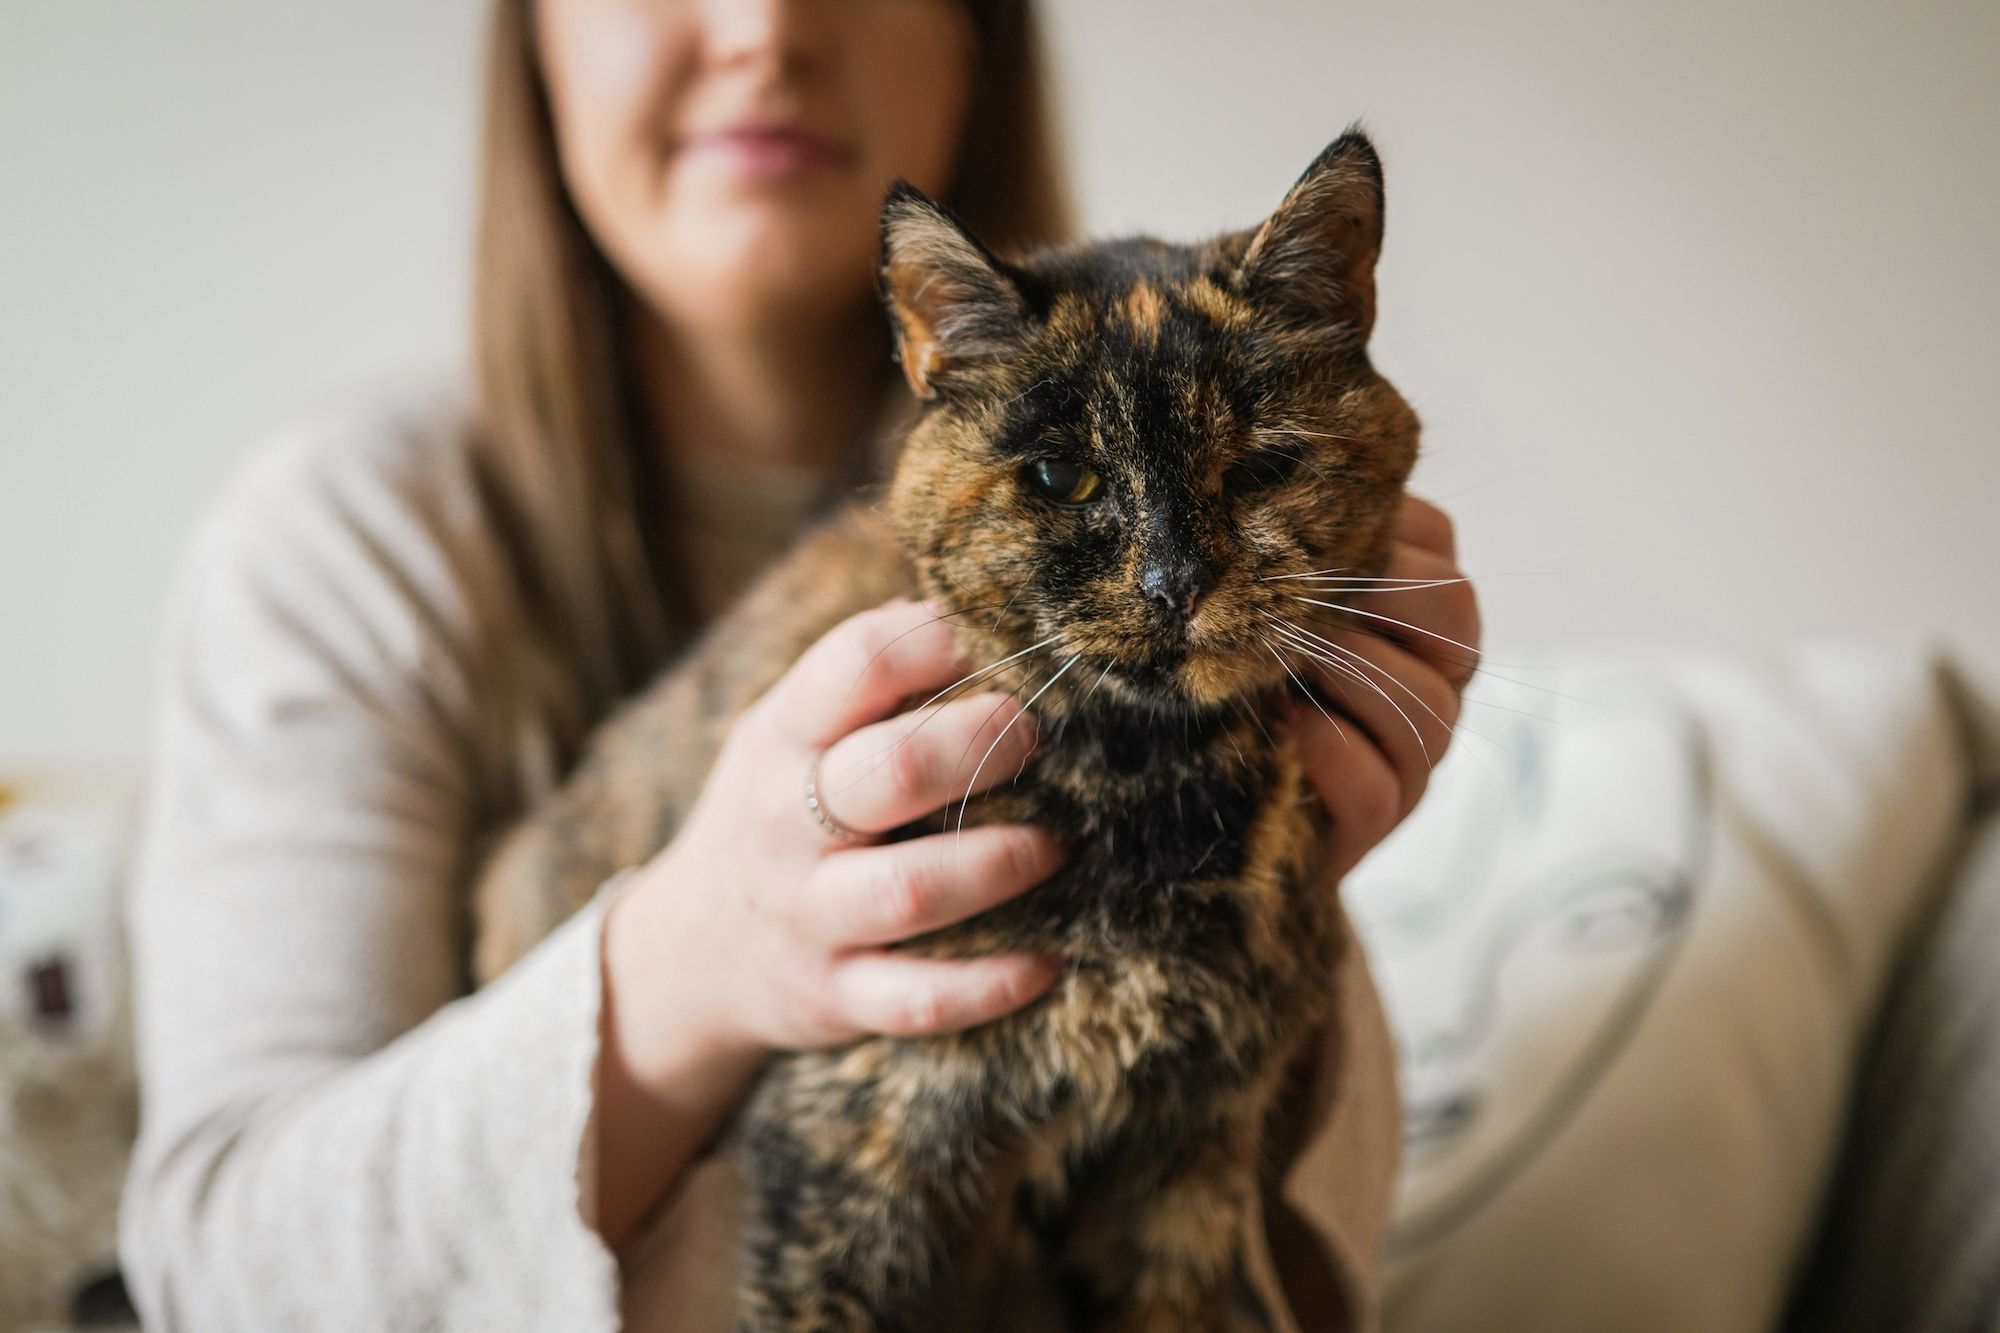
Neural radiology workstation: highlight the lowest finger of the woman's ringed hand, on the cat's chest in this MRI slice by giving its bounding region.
[828,951,1064,1037]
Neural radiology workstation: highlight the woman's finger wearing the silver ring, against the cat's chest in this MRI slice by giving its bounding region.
[816,695,1034,833]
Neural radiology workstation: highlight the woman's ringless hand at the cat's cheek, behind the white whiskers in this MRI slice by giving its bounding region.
[1292,496,1480,875]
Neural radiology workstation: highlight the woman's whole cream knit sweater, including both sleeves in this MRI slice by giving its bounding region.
[122,376,1396,1333]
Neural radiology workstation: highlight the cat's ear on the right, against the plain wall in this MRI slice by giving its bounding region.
[1242,128,1382,346]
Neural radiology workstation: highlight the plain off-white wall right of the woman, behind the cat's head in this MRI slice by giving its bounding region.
[1060,0,2000,664]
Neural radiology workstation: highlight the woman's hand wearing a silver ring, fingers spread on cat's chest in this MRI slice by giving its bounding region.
[608,600,1062,1069]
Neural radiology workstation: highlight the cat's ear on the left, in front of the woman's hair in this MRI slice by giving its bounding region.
[882,180,1028,398]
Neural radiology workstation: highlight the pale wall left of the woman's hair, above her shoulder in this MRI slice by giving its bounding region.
[0,0,484,763]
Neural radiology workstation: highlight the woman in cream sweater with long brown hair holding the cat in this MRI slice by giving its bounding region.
[122,0,1476,1333]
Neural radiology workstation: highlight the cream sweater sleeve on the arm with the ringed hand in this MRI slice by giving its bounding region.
[120,418,620,1333]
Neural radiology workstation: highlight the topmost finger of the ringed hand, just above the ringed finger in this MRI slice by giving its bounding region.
[760,600,968,747]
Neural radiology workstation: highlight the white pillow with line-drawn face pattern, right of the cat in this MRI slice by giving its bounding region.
[1348,646,1966,1333]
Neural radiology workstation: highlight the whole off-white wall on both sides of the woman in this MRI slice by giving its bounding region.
[0,0,2000,761]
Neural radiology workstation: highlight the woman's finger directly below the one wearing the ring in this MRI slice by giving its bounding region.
[798,825,1064,947]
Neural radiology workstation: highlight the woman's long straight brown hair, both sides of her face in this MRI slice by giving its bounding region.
[472,0,1070,715]
